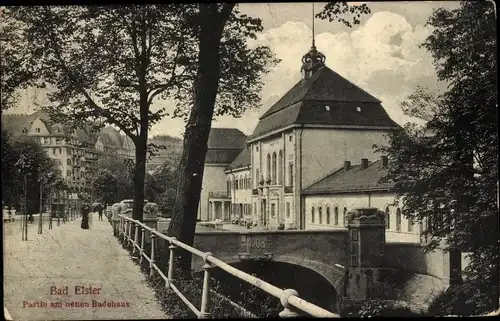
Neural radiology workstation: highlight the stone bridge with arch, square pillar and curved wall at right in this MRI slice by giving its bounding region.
[145,208,460,308]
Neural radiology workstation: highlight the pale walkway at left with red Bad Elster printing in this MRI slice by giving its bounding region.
[4,216,166,321]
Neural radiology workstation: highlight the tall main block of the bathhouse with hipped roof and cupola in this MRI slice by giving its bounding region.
[247,46,399,229]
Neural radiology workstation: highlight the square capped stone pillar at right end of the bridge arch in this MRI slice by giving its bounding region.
[344,208,386,304]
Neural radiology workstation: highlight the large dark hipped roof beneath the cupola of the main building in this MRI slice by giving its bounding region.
[249,66,399,139]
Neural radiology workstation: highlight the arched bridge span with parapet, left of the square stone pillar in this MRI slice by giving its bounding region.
[193,230,348,294]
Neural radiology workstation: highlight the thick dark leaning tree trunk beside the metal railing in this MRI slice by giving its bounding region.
[168,3,234,278]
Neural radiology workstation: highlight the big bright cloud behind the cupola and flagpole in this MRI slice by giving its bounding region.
[252,11,437,123]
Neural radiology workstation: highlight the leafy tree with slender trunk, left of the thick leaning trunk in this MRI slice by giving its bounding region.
[3,4,278,220]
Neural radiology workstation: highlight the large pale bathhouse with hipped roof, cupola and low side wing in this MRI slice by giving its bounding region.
[218,40,419,241]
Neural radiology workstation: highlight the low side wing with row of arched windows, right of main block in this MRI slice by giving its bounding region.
[301,156,423,243]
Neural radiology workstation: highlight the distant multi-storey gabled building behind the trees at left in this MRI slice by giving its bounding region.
[2,111,134,192]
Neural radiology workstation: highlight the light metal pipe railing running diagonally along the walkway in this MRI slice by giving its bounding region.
[118,215,340,319]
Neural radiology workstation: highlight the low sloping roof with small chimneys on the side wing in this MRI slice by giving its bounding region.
[302,161,392,195]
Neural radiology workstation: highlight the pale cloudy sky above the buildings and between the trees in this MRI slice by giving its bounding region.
[10,1,459,136]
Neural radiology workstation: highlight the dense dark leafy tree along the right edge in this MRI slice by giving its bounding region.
[380,1,499,314]
